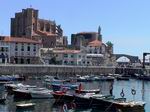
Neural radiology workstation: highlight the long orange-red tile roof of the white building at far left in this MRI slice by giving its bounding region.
[3,36,42,44]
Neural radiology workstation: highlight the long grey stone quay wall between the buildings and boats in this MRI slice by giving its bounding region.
[0,64,149,75]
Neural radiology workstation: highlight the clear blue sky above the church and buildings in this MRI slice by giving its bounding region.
[0,0,150,57]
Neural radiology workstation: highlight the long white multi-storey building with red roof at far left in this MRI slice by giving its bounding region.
[0,36,42,64]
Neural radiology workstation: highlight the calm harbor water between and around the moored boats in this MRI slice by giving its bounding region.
[0,79,150,112]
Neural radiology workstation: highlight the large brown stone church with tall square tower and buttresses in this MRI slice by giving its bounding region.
[11,8,63,47]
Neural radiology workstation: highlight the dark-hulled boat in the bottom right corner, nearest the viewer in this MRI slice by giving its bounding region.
[91,97,145,111]
